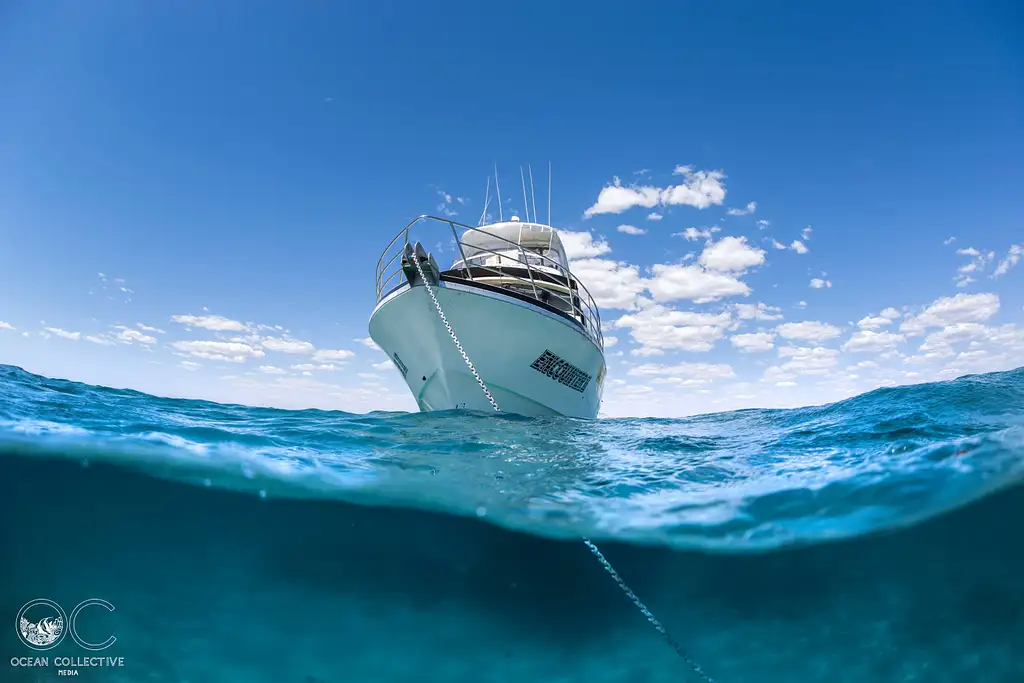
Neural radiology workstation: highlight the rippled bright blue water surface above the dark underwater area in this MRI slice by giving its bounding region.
[0,366,1024,552]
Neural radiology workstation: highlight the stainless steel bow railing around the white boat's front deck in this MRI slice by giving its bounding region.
[376,215,604,349]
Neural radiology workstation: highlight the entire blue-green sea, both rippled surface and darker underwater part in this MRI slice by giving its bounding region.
[0,366,1024,683]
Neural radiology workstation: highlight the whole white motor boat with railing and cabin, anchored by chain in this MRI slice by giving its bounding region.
[369,172,606,419]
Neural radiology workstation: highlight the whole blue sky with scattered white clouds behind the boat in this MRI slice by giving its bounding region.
[0,0,1024,415]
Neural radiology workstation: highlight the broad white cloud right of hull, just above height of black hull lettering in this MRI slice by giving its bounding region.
[614,304,732,355]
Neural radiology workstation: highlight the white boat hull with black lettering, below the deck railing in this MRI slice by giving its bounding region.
[370,282,605,418]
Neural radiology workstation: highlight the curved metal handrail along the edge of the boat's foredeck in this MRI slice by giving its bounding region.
[375,214,604,349]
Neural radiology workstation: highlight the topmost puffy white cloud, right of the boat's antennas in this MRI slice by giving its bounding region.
[584,166,725,218]
